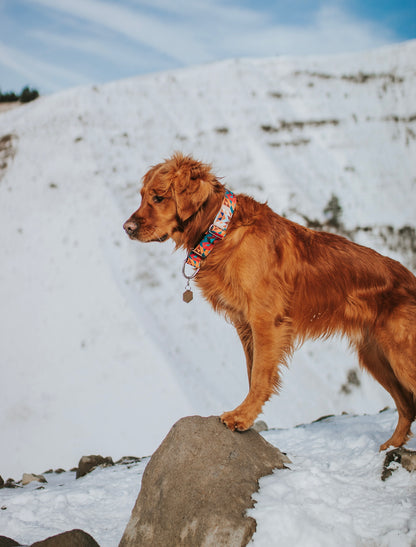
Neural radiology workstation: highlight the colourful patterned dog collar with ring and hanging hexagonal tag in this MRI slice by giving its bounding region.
[182,190,237,302]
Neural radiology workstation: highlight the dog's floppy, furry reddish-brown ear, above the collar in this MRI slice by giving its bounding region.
[171,156,213,221]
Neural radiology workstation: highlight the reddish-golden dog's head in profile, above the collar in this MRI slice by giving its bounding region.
[123,153,219,242]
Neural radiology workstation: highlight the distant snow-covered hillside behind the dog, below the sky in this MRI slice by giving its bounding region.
[0,42,416,477]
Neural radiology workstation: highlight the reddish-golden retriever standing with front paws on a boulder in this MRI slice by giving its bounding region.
[124,153,416,450]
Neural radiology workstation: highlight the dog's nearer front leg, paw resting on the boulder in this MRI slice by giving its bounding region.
[221,320,292,431]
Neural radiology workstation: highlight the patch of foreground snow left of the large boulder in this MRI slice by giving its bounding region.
[0,458,148,547]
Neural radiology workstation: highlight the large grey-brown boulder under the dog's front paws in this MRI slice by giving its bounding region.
[119,416,289,547]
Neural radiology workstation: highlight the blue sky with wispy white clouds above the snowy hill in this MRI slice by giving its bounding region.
[0,0,416,93]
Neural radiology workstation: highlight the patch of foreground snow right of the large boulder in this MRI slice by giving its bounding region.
[250,411,416,547]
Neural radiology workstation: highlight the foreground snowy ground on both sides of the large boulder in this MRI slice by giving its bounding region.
[0,411,416,547]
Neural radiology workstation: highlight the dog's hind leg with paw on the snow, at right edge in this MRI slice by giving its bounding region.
[357,337,415,450]
